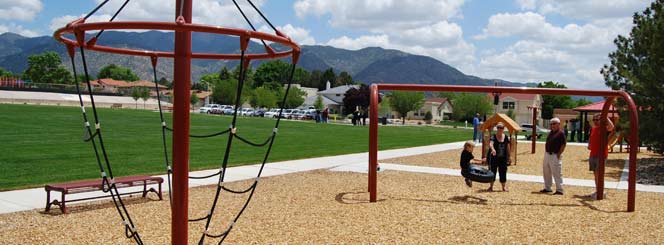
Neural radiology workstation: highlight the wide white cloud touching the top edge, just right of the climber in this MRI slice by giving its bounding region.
[293,0,464,32]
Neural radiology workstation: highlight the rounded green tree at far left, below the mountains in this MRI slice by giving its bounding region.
[23,52,73,84]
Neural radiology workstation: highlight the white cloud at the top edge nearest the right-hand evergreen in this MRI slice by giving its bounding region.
[516,0,651,20]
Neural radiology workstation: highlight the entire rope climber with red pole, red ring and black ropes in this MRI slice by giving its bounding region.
[53,0,300,244]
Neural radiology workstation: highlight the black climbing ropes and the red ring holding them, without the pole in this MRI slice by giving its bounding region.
[54,0,300,244]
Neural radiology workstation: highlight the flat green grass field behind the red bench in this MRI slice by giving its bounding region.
[0,104,472,190]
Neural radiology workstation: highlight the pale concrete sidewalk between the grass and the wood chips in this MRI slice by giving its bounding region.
[0,142,664,213]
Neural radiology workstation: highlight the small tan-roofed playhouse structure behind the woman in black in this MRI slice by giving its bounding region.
[480,113,522,165]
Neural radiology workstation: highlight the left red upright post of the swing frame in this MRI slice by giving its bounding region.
[369,84,378,202]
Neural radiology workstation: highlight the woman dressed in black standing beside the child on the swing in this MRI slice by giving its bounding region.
[487,122,512,191]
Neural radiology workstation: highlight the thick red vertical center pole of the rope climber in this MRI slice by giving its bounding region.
[171,0,192,244]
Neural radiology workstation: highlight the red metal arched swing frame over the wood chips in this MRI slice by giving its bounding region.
[368,84,639,212]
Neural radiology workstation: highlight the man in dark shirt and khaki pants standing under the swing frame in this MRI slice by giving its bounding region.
[540,117,567,195]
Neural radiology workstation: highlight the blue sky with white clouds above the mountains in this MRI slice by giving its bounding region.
[0,0,651,89]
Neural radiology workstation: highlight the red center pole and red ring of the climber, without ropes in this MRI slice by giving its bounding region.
[53,0,300,244]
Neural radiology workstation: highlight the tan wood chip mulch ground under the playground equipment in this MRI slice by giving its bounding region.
[0,168,664,244]
